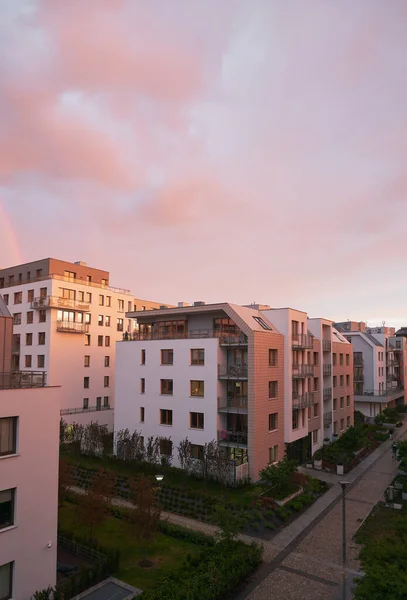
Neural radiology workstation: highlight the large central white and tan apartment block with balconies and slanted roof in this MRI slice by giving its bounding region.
[114,302,353,480]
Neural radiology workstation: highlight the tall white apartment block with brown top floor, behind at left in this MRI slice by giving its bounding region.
[0,258,169,428]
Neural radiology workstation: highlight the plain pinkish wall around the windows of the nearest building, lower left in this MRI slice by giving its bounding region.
[0,388,60,600]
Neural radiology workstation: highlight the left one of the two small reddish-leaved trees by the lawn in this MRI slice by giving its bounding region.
[79,469,115,539]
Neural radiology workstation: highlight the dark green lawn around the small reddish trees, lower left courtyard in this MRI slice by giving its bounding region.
[59,502,201,590]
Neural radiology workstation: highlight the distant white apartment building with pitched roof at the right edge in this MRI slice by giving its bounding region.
[336,321,407,419]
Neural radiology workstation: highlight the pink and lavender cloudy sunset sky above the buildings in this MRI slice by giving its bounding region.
[0,0,407,326]
